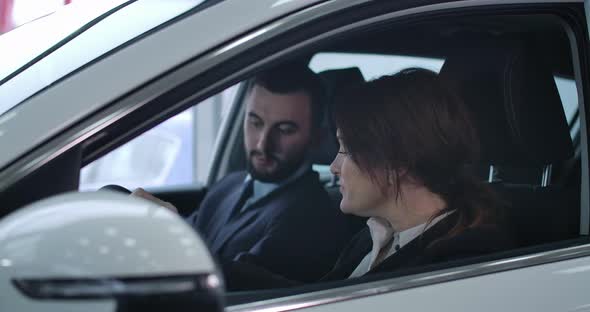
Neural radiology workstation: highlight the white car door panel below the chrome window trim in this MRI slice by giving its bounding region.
[274,258,590,312]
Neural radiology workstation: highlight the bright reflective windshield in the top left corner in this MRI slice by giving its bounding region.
[0,0,208,115]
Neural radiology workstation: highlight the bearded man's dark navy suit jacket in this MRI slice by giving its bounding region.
[188,169,351,281]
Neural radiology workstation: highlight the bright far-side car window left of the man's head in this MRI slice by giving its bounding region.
[80,85,238,190]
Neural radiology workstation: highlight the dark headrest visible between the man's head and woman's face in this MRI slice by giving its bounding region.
[311,67,365,165]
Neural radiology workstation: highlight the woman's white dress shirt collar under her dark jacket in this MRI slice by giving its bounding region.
[349,211,452,278]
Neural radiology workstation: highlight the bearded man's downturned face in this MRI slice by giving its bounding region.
[244,85,312,182]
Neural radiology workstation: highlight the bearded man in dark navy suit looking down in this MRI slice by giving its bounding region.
[188,66,350,282]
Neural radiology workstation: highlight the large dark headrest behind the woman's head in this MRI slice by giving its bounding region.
[439,39,573,167]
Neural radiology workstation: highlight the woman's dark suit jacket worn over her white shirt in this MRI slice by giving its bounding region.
[225,213,514,290]
